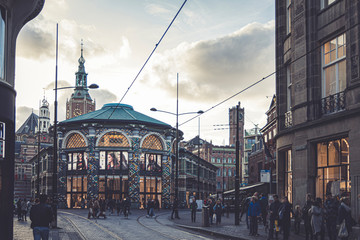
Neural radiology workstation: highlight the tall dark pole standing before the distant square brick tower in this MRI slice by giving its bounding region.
[235,103,240,225]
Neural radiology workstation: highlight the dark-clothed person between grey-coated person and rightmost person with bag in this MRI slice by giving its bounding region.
[324,193,339,240]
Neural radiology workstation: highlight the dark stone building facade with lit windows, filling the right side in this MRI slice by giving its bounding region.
[276,0,360,219]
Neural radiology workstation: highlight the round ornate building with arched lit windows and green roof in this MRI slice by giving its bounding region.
[59,104,175,208]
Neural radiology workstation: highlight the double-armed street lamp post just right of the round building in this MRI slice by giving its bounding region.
[150,74,204,204]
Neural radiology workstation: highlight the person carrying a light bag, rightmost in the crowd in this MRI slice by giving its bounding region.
[338,197,356,240]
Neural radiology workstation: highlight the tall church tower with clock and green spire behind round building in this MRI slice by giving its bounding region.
[66,41,95,119]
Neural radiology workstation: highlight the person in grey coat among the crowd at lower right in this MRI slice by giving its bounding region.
[309,198,324,240]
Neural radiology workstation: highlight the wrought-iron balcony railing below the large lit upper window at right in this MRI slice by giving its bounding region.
[320,92,346,115]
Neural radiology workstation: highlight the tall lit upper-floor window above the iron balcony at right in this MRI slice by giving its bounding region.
[322,34,346,98]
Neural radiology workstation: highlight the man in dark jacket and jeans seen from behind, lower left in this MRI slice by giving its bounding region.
[30,194,53,240]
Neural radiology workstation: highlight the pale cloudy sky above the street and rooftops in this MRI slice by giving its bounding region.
[15,0,275,145]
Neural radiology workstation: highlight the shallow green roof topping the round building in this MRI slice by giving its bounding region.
[61,103,171,128]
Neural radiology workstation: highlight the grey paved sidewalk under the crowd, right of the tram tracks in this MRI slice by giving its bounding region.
[169,210,305,240]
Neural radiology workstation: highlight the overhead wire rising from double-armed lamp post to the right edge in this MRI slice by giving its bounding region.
[179,22,360,127]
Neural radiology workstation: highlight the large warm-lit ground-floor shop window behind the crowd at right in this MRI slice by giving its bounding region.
[316,138,351,199]
